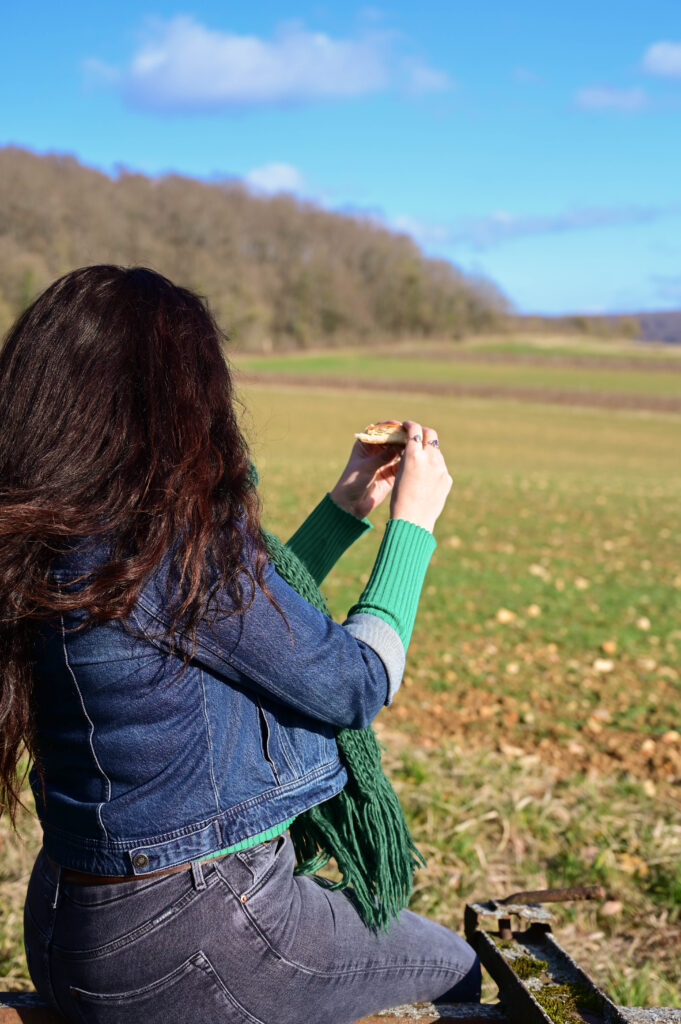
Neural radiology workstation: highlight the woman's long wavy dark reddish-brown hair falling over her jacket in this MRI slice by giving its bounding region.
[0,265,265,821]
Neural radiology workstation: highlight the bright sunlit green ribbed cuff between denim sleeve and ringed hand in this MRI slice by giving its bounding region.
[348,519,436,650]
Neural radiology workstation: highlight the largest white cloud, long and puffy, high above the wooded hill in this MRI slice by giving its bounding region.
[86,15,449,113]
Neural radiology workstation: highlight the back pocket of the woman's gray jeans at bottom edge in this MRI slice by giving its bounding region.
[71,949,261,1024]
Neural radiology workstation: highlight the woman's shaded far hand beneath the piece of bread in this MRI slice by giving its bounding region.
[330,441,400,519]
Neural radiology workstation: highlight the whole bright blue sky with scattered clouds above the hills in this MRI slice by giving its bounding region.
[0,0,681,312]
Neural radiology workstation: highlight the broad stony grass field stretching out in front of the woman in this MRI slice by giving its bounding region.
[0,346,681,1006]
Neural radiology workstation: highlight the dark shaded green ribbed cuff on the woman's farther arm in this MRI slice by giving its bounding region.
[286,495,373,586]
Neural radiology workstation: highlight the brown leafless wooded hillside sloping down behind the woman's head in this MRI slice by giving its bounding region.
[0,146,508,349]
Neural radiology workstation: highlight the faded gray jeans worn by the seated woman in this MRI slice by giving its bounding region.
[25,836,480,1024]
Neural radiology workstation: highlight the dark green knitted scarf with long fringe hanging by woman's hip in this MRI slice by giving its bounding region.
[263,532,425,931]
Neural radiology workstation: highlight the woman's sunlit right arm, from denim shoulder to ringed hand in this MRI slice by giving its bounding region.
[138,424,452,728]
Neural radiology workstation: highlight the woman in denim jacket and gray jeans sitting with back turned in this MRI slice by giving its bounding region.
[0,266,479,1024]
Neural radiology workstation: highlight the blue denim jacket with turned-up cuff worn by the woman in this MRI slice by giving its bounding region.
[31,499,403,874]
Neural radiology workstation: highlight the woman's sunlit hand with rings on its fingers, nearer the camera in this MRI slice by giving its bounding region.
[390,420,452,534]
